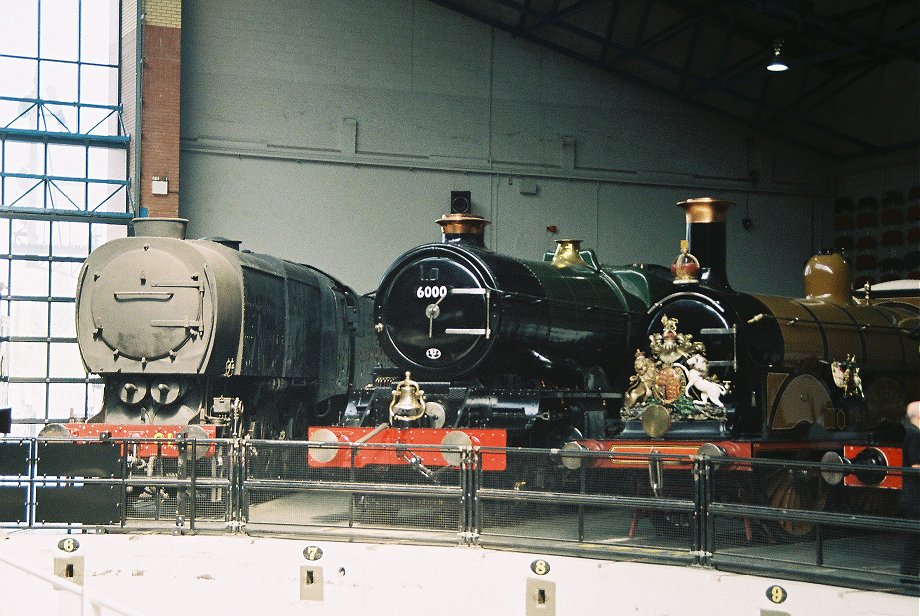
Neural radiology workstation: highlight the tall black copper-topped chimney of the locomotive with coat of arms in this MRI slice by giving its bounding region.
[677,197,734,289]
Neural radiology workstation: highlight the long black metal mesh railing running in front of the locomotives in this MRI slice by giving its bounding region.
[0,439,920,593]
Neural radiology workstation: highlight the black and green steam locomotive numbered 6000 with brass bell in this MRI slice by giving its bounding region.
[310,207,670,467]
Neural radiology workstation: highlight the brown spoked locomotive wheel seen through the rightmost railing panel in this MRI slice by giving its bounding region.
[765,469,828,540]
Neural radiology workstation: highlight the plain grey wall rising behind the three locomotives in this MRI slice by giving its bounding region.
[180,0,833,295]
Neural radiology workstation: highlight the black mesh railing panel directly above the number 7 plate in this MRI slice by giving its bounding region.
[243,441,466,538]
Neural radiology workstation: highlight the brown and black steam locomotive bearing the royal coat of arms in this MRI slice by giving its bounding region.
[563,199,920,535]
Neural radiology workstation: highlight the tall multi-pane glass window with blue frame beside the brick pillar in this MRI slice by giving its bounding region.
[0,0,131,434]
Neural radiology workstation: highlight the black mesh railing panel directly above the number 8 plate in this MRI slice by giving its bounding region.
[475,449,697,558]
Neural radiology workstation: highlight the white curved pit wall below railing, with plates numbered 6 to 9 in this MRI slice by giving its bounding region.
[0,531,920,616]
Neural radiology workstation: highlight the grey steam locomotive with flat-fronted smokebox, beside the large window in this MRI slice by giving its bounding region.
[42,218,382,448]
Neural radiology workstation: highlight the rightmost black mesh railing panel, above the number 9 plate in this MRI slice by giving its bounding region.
[705,460,920,586]
